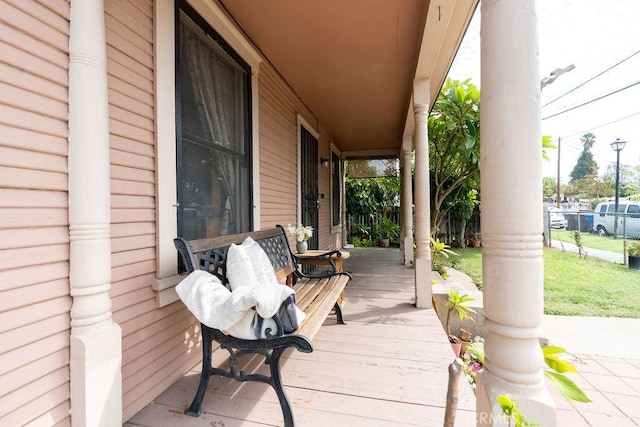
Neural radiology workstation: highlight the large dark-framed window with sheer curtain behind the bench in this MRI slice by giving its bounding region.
[176,4,252,239]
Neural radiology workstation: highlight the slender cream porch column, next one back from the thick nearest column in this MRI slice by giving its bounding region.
[413,79,432,308]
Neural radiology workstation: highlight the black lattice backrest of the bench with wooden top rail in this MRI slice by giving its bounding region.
[173,225,295,285]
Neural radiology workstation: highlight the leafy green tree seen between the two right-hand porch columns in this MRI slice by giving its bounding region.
[429,79,480,235]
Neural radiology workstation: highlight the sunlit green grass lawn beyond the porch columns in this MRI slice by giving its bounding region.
[454,248,640,318]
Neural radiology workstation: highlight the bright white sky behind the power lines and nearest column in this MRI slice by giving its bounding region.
[449,0,640,183]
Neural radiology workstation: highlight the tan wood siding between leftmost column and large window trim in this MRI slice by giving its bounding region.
[105,0,200,421]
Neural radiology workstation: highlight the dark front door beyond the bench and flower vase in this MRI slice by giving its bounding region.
[300,126,319,249]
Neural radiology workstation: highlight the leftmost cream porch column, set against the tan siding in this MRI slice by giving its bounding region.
[69,0,122,427]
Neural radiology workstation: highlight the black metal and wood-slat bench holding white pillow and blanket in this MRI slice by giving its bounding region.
[174,225,351,427]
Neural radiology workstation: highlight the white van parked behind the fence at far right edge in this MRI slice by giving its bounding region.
[593,201,640,239]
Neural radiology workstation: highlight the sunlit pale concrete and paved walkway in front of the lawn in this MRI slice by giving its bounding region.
[446,270,640,427]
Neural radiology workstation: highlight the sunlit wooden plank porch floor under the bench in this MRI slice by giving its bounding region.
[125,248,476,427]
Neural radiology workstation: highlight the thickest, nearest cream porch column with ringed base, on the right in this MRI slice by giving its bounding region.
[476,0,556,426]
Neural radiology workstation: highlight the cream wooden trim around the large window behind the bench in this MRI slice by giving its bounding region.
[152,0,263,307]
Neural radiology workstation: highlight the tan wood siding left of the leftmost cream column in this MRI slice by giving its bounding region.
[0,0,71,425]
